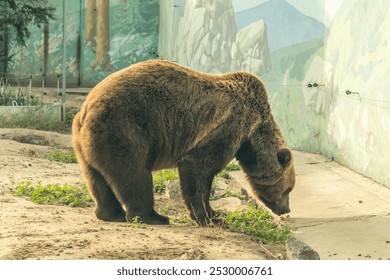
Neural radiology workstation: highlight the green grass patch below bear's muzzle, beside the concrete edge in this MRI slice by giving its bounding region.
[223,205,291,244]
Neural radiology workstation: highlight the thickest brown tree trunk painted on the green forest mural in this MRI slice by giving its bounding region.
[93,0,112,71]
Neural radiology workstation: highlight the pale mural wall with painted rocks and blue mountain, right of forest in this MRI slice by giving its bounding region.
[159,0,390,187]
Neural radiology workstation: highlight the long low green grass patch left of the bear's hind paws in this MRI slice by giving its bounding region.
[14,182,94,207]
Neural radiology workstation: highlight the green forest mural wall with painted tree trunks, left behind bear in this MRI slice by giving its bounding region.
[8,0,159,86]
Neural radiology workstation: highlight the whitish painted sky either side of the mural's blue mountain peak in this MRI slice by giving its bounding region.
[232,0,344,27]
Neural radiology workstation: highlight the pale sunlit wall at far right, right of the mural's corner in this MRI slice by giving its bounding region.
[314,0,390,187]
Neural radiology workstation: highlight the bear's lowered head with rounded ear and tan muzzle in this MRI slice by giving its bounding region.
[236,124,295,215]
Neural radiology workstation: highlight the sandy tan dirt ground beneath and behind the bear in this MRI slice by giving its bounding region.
[0,129,286,260]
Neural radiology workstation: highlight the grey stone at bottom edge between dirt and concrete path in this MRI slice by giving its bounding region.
[286,237,320,260]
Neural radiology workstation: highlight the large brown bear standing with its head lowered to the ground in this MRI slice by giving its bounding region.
[72,60,295,225]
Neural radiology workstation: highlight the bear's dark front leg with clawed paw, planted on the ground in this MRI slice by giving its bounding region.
[178,160,222,226]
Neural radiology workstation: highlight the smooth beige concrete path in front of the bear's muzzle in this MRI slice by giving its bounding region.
[233,152,390,260]
